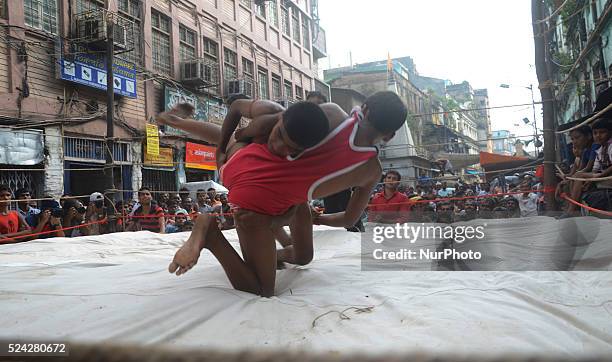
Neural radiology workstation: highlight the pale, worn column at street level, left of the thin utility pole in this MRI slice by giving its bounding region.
[44,127,64,197]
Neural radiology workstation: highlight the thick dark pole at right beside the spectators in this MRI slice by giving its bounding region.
[531,0,557,211]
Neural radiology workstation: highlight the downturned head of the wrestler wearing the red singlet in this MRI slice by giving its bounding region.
[361,91,408,143]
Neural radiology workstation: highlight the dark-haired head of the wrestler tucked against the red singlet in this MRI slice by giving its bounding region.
[268,102,329,157]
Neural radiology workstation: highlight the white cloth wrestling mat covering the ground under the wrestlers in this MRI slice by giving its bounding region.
[0,217,612,357]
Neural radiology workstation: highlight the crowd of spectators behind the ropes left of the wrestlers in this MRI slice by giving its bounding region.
[0,185,234,244]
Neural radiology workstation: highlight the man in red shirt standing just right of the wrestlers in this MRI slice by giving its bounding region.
[368,170,410,224]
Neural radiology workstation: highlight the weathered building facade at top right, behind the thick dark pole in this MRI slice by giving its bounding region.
[543,0,612,125]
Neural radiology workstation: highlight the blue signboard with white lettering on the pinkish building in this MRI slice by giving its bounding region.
[60,53,136,98]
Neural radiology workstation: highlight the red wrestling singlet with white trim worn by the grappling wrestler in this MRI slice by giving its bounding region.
[220,112,378,215]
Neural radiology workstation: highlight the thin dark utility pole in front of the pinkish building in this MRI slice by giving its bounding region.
[104,13,116,232]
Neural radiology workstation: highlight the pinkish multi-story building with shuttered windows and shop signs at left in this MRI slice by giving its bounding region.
[0,0,329,201]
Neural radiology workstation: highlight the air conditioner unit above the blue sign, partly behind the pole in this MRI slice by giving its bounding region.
[77,16,127,50]
